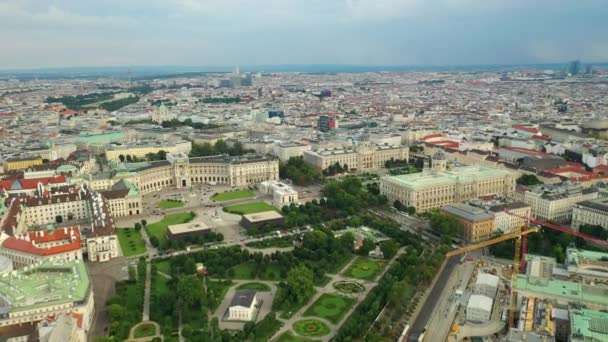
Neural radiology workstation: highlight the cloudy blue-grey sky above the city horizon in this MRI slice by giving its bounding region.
[0,0,608,70]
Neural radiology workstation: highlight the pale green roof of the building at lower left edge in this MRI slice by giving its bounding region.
[0,261,91,313]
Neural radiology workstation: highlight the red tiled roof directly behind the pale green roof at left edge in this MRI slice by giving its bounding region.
[2,227,81,256]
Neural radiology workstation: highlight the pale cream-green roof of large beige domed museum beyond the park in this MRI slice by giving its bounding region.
[382,165,513,190]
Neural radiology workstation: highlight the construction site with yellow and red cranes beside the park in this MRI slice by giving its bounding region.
[403,214,608,342]
